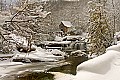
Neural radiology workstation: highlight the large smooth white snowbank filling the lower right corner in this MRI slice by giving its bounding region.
[53,44,120,80]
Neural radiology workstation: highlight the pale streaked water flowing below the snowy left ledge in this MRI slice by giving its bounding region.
[0,62,61,80]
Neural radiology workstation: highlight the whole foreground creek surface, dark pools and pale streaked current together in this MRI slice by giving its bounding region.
[1,52,88,80]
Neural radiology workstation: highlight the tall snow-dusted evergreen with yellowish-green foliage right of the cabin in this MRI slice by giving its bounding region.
[88,0,113,55]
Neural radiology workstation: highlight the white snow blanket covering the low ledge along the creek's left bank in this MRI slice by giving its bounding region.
[13,47,64,61]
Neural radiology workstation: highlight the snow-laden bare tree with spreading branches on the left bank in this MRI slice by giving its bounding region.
[3,0,50,52]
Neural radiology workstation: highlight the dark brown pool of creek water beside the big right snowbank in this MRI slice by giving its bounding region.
[48,55,88,75]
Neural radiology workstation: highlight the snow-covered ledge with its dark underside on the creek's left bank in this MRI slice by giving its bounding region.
[13,47,64,63]
